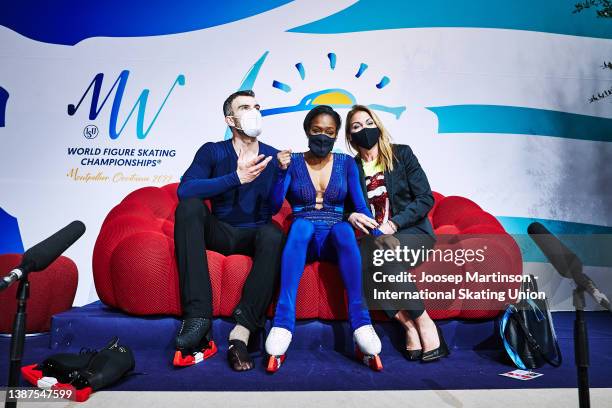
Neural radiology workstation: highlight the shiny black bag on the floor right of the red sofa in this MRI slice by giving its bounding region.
[499,275,562,370]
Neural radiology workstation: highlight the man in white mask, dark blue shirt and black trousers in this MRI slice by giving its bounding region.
[174,90,284,371]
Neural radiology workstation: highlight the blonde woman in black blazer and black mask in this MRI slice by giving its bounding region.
[345,105,449,361]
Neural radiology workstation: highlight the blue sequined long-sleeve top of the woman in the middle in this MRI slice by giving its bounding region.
[270,153,382,236]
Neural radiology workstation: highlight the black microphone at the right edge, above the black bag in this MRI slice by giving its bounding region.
[527,222,612,311]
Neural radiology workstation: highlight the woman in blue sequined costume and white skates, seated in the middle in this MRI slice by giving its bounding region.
[266,105,382,372]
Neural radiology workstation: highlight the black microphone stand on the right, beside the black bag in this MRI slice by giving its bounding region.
[573,286,591,408]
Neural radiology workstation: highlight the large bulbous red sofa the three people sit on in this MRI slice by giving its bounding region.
[93,184,522,320]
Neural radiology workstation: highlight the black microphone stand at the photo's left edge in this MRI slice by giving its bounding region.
[4,273,30,408]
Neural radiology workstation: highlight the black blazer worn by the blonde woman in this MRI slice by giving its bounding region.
[344,144,435,239]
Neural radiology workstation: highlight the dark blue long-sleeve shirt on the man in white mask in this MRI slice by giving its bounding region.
[177,139,282,228]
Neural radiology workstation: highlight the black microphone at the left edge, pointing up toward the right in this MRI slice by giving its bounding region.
[0,221,85,290]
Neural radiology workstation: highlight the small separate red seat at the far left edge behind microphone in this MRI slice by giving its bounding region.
[0,254,79,333]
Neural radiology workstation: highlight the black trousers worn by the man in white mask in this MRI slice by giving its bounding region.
[174,198,284,331]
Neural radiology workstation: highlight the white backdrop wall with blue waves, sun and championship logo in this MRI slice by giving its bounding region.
[0,0,612,308]
